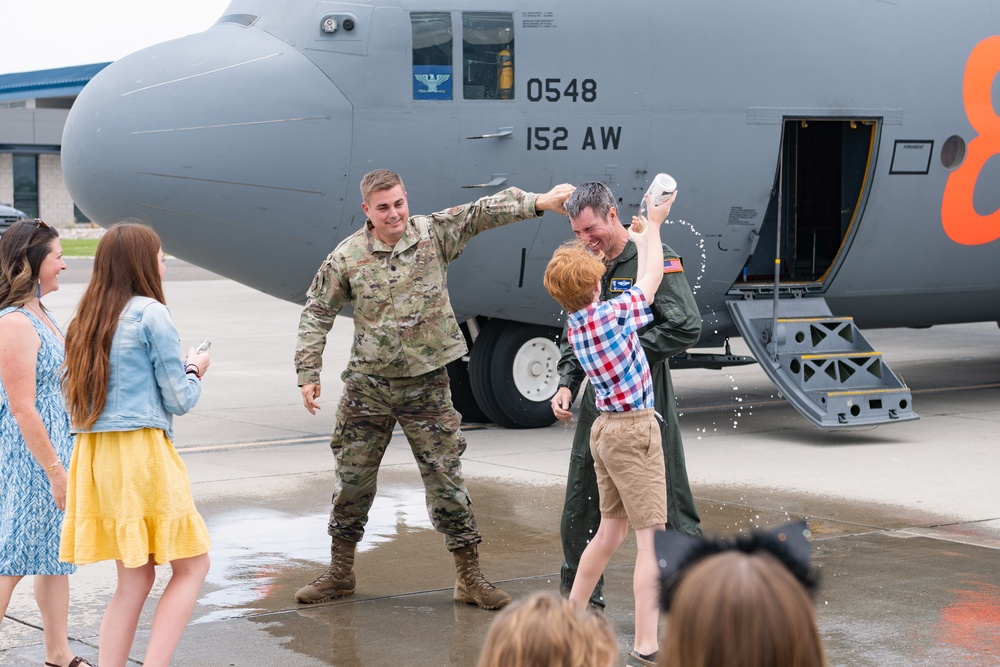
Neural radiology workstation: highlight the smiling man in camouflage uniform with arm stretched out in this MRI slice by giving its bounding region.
[295,169,573,609]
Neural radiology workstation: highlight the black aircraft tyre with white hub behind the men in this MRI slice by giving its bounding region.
[462,319,561,428]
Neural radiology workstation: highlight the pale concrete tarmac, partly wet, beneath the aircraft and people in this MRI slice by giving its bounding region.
[0,270,1000,667]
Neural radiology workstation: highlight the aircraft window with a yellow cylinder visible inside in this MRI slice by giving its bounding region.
[462,12,514,100]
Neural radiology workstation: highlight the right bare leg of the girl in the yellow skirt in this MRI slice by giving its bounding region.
[142,554,210,667]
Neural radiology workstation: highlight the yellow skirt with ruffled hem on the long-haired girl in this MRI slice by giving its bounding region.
[59,428,211,567]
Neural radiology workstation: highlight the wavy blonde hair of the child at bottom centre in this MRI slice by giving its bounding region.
[476,593,618,667]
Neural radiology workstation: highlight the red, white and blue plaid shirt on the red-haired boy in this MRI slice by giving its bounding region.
[568,289,653,412]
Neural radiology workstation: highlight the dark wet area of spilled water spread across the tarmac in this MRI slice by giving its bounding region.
[189,470,1000,667]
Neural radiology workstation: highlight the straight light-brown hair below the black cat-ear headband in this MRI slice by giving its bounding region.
[657,551,826,667]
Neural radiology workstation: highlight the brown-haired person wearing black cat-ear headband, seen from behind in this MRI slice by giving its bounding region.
[654,521,827,667]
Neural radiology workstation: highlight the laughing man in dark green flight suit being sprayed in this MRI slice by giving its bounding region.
[552,183,701,608]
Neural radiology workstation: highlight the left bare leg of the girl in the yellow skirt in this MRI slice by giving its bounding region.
[98,556,156,667]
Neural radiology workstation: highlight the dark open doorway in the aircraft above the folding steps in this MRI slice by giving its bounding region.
[739,118,878,289]
